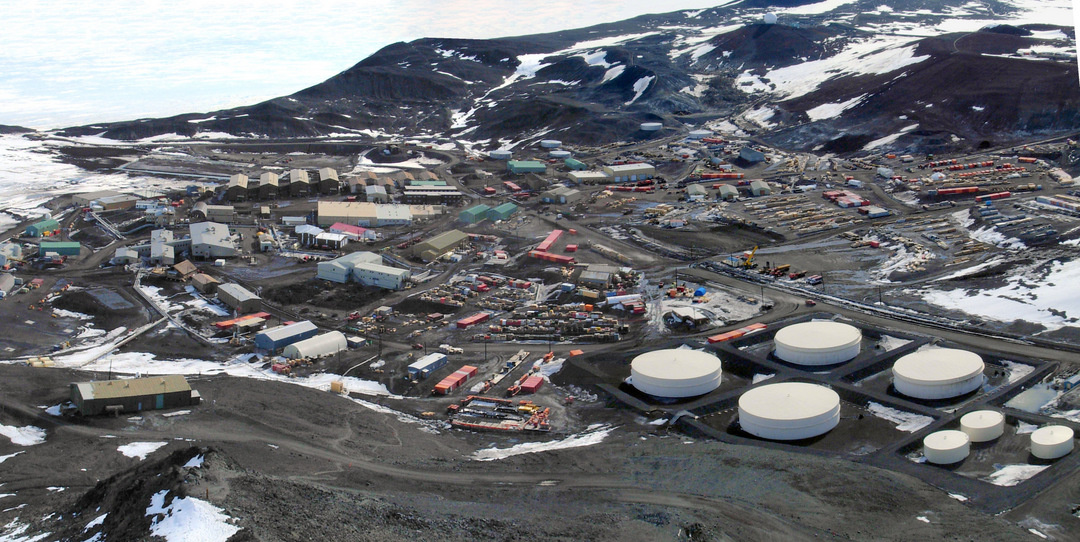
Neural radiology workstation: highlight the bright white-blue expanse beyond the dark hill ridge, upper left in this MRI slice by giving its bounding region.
[0,0,732,128]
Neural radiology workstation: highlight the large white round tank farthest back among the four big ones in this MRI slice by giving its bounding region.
[773,322,863,365]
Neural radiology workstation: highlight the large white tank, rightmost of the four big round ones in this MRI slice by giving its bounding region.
[892,348,986,399]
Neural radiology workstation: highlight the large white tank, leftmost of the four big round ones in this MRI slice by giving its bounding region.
[630,349,723,398]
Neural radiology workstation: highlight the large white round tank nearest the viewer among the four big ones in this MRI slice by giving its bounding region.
[739,382,840,441]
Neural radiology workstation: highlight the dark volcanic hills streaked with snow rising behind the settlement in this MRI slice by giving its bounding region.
[63,0,1080,152]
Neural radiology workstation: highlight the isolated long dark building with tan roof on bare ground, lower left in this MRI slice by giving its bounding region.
[71,375,202,416]
